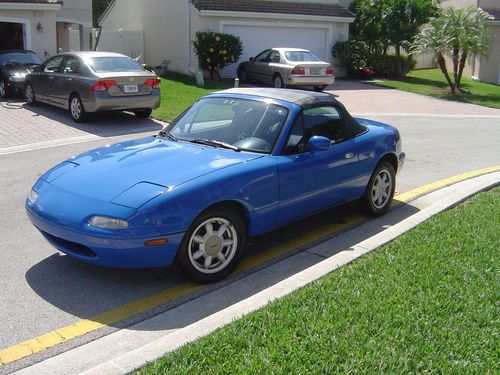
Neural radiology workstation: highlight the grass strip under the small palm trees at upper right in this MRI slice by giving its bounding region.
[373,69,500,108]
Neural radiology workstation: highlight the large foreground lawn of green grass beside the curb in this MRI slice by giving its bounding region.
[139,188,500,374]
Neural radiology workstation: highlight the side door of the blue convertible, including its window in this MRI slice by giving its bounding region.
[278,105,360,225]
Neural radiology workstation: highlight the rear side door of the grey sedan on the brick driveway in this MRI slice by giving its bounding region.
[53,56,81,108]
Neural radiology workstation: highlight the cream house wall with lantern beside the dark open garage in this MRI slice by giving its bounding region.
[0,9,57,58]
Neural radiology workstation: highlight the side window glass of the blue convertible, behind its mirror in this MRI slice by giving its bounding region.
[303,107,347,143]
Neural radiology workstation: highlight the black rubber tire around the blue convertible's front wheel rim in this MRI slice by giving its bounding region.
[176,207,247,284]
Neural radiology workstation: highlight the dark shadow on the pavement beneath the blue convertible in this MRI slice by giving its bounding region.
[25,204,419,330]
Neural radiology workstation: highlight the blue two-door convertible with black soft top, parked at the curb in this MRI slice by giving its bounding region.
[26,88,405,282]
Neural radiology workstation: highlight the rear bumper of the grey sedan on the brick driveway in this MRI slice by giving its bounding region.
[82,89,160,112]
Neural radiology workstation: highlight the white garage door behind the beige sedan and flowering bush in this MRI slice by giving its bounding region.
[222,25,330,78]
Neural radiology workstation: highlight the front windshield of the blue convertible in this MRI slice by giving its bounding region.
[164,97,288,153]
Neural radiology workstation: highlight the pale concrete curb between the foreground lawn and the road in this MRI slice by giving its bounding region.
[13,172,500,375]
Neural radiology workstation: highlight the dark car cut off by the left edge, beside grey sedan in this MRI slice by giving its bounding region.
[0,50,42,98]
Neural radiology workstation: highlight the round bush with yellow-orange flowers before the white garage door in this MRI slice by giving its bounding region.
[193,31,243,78]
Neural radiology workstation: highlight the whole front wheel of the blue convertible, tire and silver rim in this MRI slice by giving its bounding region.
[176,207,247,283]
